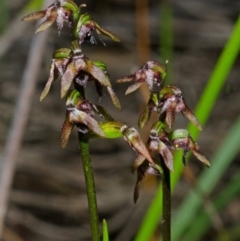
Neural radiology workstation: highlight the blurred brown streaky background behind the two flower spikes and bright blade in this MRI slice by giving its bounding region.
[0,0,240,241]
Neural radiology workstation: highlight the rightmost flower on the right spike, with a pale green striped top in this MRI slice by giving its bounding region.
[170,129,210,167]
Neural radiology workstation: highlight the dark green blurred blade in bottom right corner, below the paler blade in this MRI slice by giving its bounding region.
[182,172,240,241]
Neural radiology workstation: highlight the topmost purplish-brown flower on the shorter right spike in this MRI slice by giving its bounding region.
[117,61,167,95]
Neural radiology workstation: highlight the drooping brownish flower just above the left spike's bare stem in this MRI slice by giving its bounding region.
[61,90,105,148]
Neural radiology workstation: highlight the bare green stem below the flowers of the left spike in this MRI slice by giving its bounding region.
[78,133,100,241]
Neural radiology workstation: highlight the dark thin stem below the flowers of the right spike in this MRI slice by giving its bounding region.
[160,156,171,241]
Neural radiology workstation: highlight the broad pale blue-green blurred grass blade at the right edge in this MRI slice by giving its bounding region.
[172,113,240,241]
